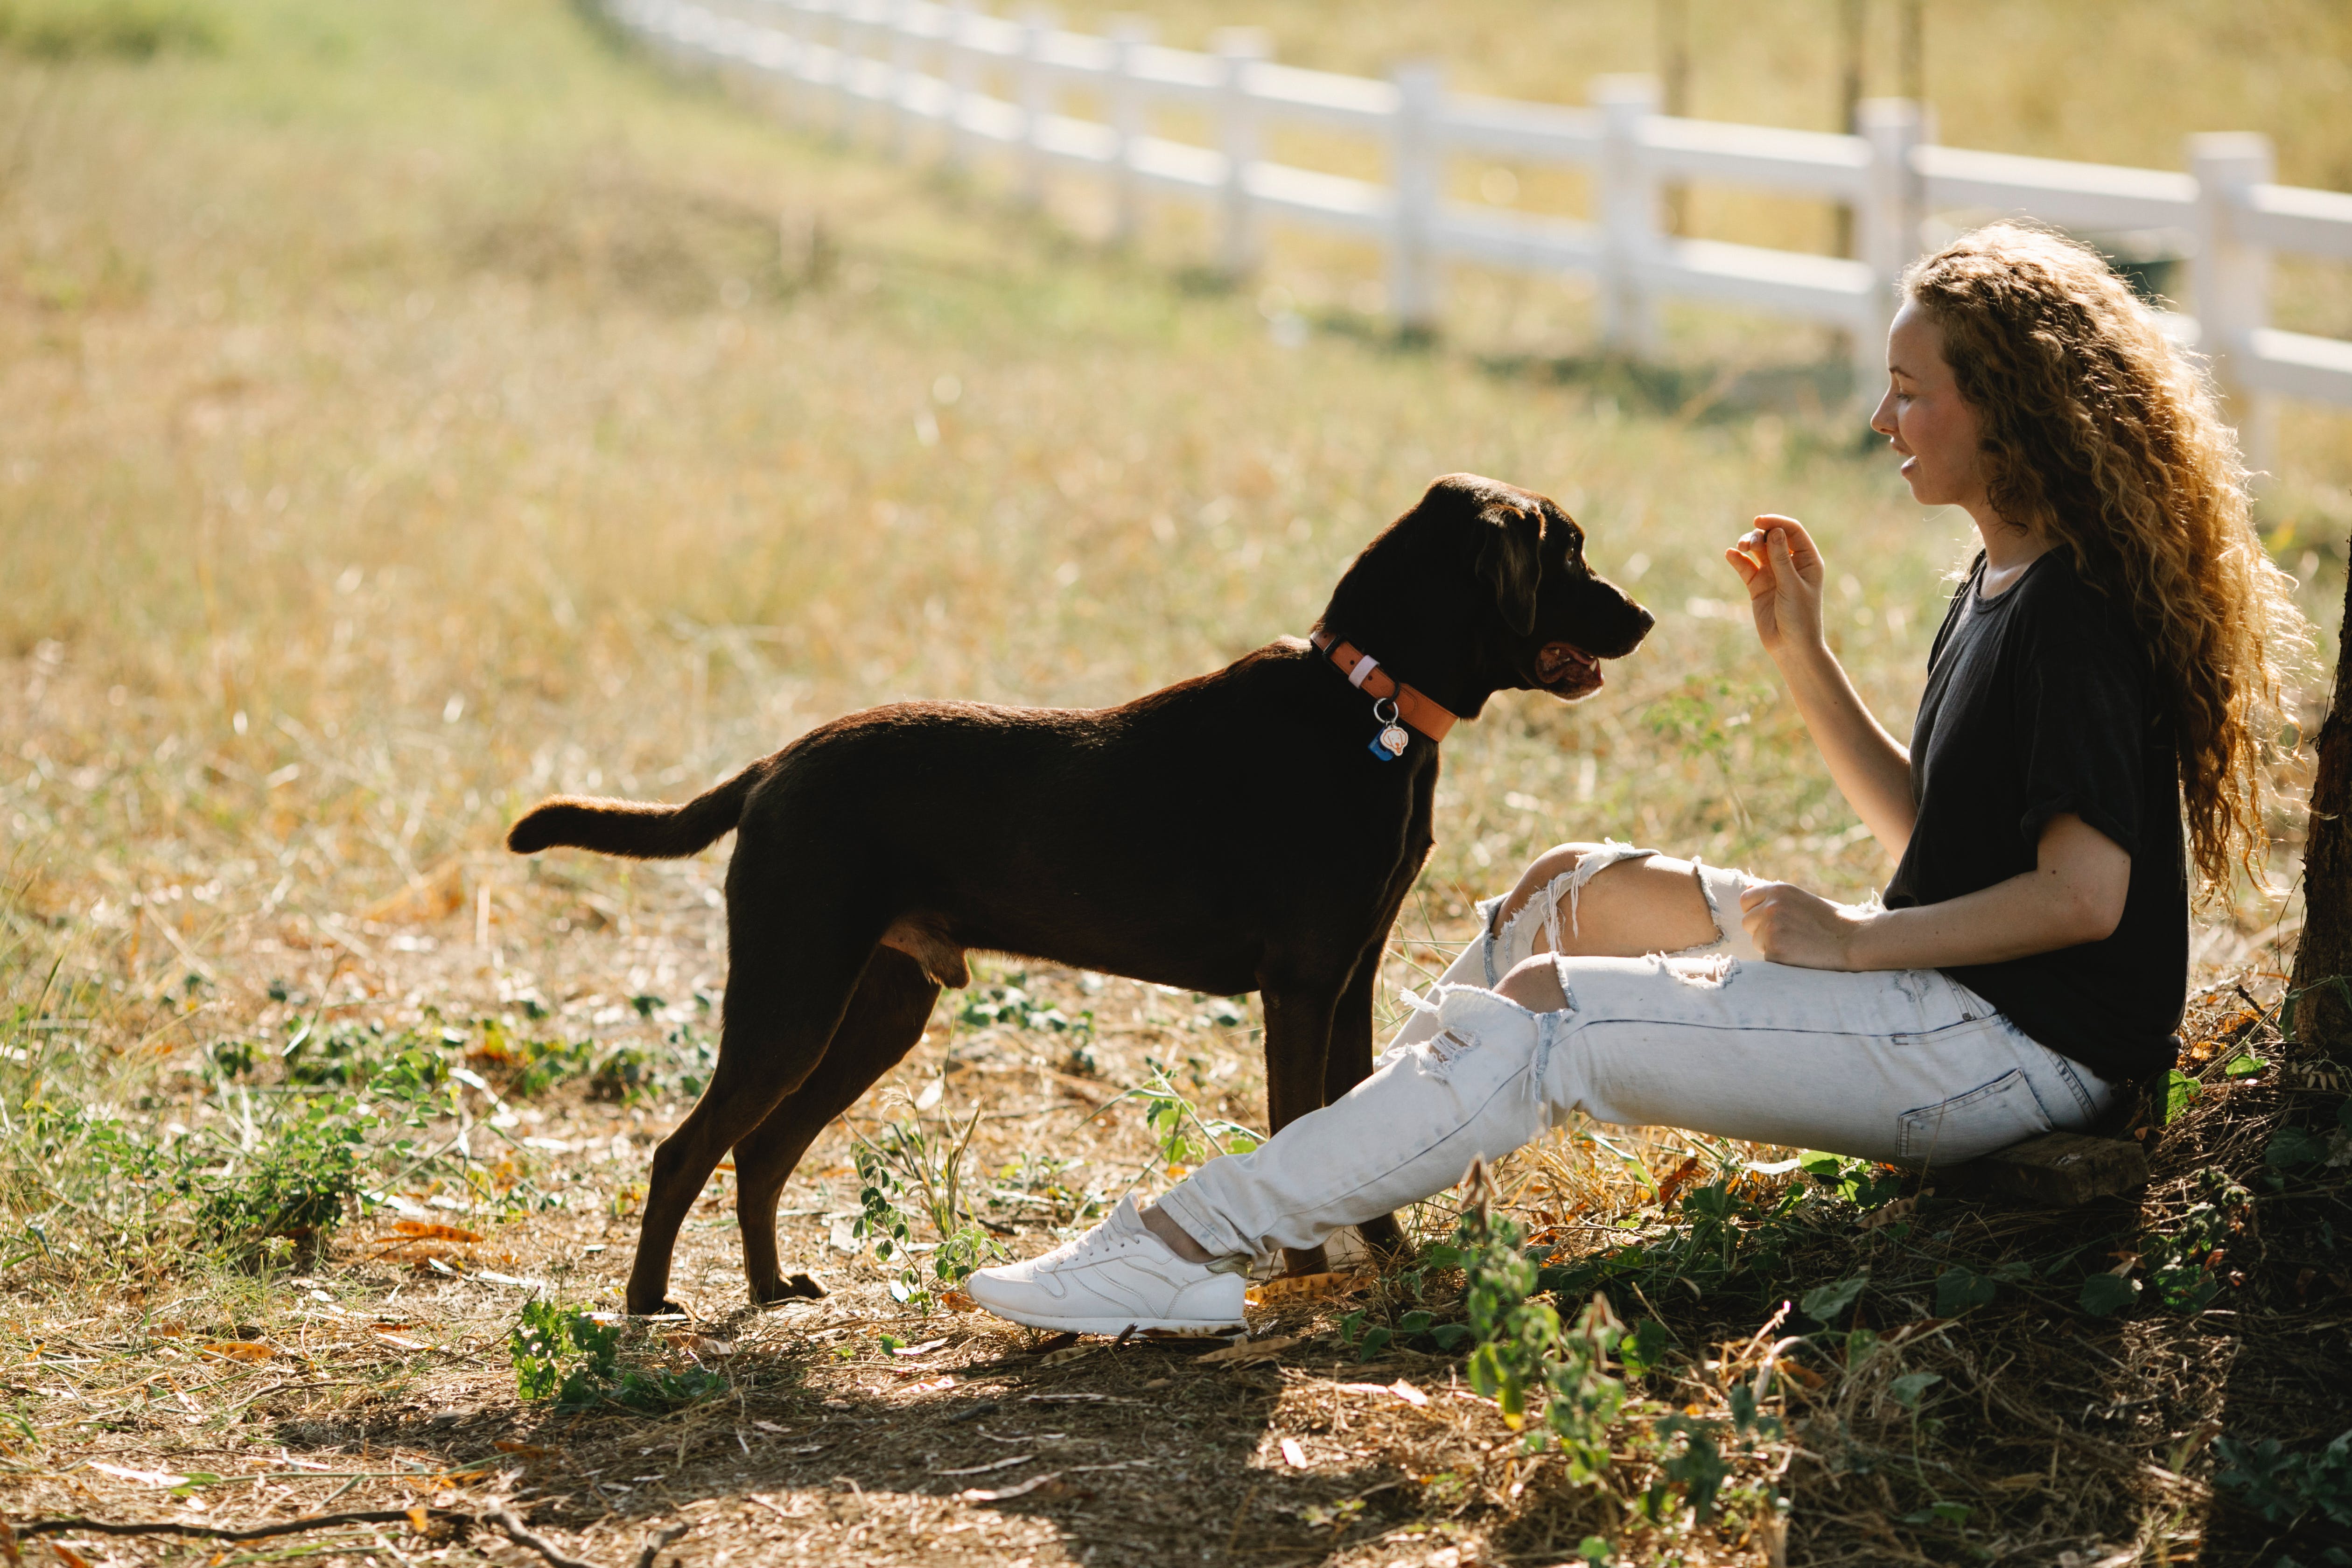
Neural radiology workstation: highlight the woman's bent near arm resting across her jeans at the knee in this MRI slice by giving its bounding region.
[1741,811,2131,968]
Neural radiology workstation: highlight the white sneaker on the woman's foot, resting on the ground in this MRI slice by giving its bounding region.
[964,1197,1249,1333]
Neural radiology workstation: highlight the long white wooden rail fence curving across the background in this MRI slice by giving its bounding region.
[607,0,2352,456]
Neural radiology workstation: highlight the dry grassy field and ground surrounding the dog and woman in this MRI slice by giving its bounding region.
[0,0,2352,1568]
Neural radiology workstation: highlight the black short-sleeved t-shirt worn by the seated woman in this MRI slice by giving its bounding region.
[1886,550,2190,1081]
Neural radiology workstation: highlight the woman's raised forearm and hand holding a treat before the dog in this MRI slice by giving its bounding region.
[1724,517,1917,861]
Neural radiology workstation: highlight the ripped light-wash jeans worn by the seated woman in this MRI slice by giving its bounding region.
[1160,844,2114,1258]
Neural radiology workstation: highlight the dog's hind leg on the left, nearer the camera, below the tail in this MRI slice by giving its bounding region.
[628,931,873,1314]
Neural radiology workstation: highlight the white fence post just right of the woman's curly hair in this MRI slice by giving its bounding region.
[2190,132,2277,484]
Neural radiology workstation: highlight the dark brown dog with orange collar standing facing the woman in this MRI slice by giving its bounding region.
[506,475,1651,1312]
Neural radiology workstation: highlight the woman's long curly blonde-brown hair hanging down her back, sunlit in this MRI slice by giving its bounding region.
[1903,224,2312,896]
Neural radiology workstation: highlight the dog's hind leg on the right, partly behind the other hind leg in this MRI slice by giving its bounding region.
[736,947,938,1305]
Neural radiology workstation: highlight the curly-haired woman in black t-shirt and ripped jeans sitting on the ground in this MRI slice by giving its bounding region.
[969,224,2310,1333]
